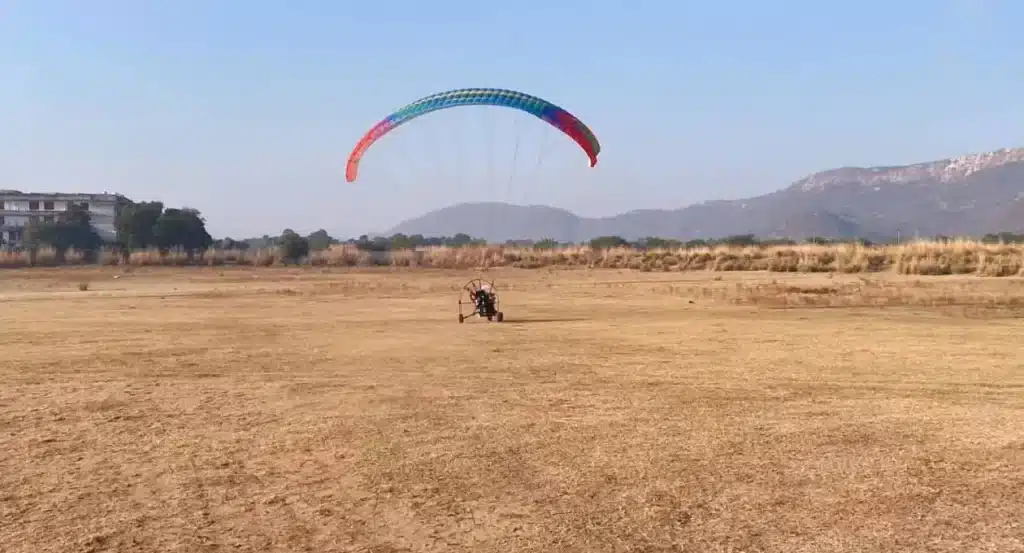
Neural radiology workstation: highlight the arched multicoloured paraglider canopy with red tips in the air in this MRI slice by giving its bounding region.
[345,88,601,182]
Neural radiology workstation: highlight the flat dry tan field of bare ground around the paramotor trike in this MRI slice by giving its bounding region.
[0,268,1024,553]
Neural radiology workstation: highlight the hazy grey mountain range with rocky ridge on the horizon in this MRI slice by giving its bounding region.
[388,147,1024,242]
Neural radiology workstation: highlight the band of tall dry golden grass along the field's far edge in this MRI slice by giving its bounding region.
[0,240,1024,277]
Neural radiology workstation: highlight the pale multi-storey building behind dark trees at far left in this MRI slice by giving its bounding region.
[0,190,128,246]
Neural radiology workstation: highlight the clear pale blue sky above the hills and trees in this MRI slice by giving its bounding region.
[0,0,1024,237]
